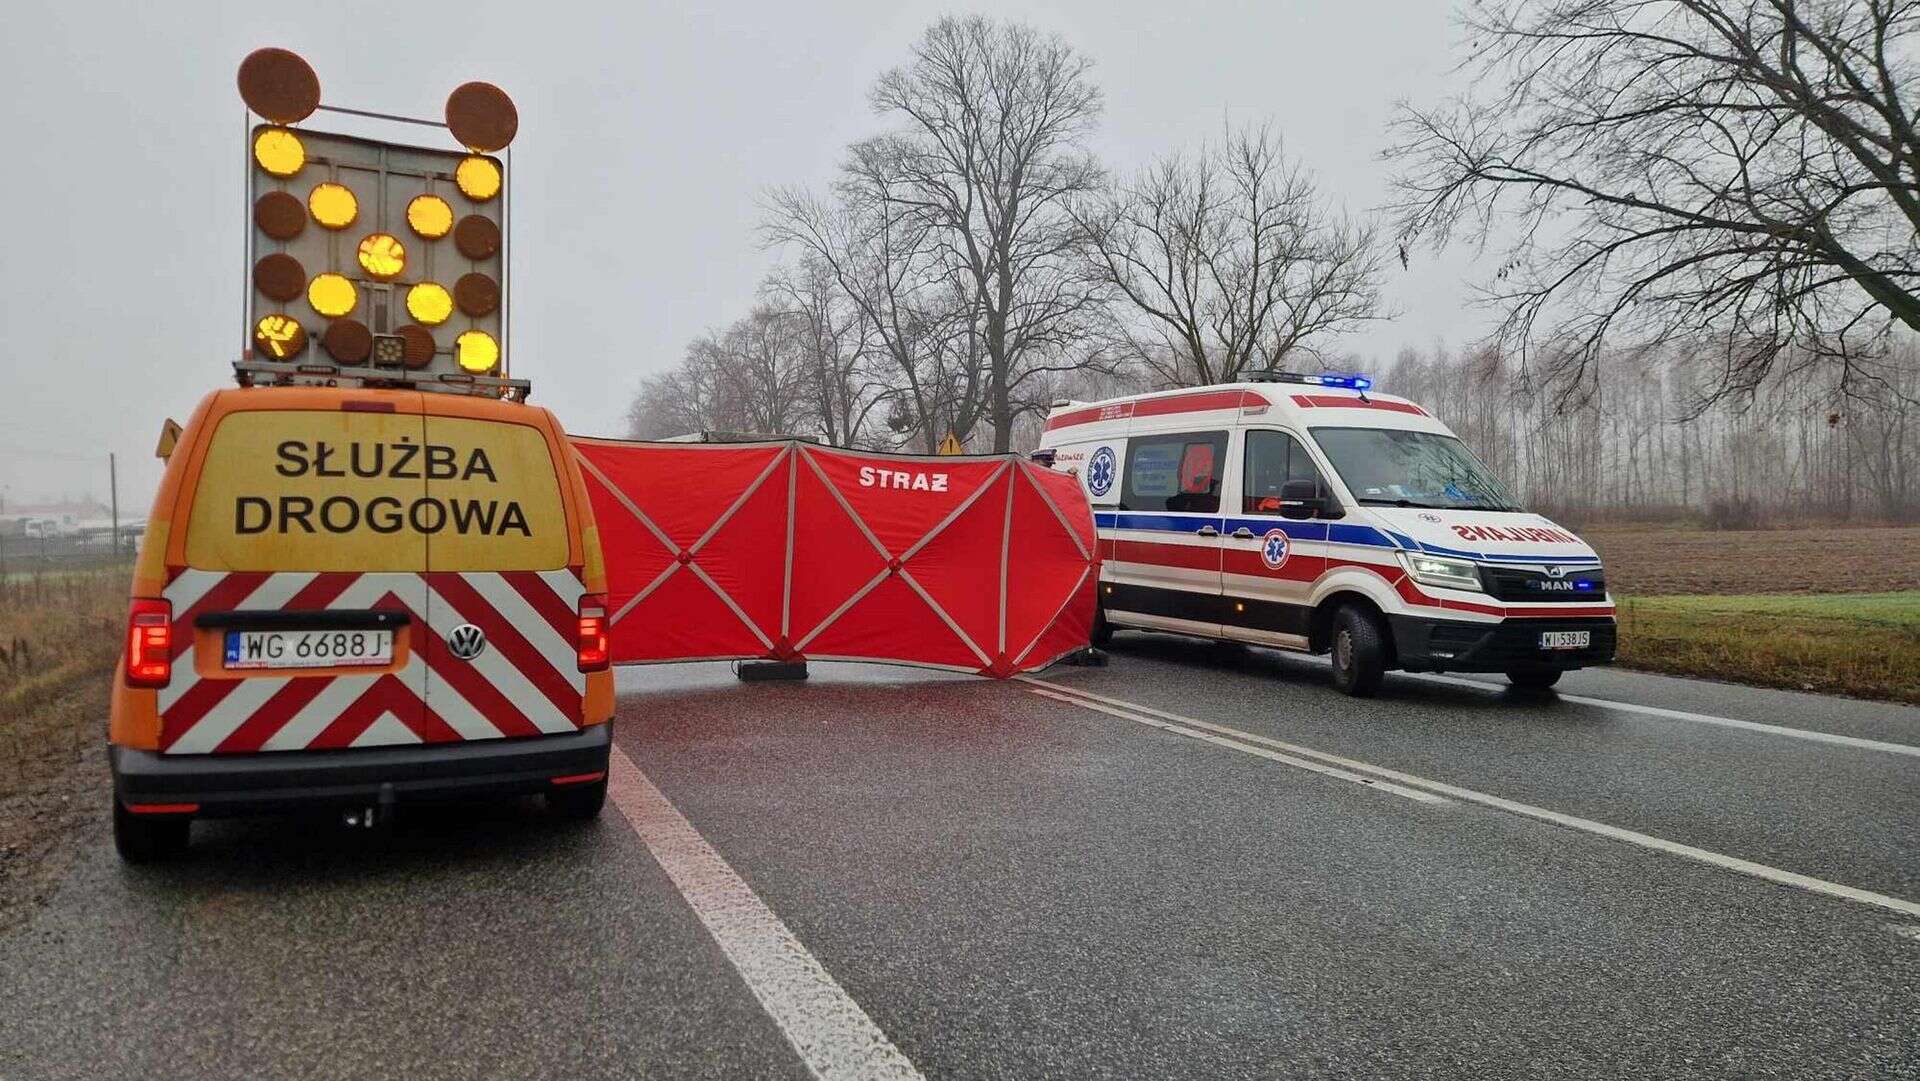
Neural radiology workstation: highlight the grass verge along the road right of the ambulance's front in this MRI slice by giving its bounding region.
[1619,589,1920,705]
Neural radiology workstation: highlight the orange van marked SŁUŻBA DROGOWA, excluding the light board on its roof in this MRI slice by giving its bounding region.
[109,386,612,858]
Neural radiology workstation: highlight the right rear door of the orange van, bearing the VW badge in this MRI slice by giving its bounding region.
[424,410,586,739]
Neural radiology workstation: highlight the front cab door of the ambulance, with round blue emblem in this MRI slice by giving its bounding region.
[1221,428,1327,649]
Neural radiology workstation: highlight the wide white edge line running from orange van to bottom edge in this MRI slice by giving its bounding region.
[607,747,925,1081]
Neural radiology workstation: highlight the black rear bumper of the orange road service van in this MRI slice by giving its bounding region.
[108,724,612,818]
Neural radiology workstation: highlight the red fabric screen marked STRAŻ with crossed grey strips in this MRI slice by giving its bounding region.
[574,440,1098,676]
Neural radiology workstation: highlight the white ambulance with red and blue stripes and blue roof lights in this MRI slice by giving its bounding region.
[1039,372,1615,695]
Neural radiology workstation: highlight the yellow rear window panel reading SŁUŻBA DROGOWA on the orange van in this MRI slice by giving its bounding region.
[186,411,568,572]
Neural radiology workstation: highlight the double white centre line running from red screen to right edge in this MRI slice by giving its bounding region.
[1020,676,1920,916]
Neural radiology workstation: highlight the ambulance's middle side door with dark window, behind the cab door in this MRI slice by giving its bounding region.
[1106,430,1227,634]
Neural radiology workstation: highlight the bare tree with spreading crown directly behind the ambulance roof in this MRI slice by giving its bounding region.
[1083,129,1380,386]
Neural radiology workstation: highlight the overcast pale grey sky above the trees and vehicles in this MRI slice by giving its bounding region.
[0,0,1484,515]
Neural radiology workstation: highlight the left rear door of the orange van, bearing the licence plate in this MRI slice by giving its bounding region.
[157,390,432,755]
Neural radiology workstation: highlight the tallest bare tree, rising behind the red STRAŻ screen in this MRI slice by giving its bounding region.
[871,15,1100,451]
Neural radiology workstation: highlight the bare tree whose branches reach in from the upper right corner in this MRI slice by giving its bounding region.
[1388,0,1920,399]
